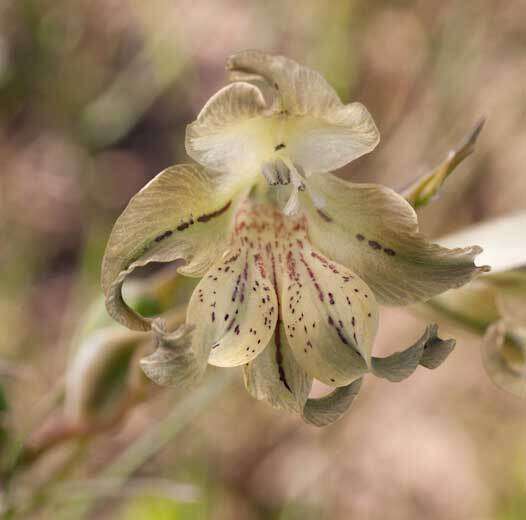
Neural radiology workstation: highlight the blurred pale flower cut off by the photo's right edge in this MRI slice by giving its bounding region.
[427,212,526,397]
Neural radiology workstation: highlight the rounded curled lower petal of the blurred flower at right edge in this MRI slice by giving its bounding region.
[481,321,526,397]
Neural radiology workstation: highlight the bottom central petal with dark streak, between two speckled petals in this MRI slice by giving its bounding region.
[243,325,312,414]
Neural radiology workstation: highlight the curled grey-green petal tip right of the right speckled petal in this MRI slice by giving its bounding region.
[371,325,455,382]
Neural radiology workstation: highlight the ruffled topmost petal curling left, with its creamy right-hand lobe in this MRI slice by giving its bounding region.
[227,51,380,173]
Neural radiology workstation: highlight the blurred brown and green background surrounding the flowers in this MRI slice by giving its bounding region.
[0,0,526,520]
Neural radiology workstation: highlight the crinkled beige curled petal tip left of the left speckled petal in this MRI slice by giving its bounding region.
[141,318,209,388]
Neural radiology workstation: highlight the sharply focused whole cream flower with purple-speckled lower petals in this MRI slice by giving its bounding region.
[102,51,488,425]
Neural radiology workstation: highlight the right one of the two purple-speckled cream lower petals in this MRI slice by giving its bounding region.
[281,245,378,386]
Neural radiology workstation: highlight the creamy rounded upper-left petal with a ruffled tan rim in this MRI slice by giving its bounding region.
[185,82,272,172]
